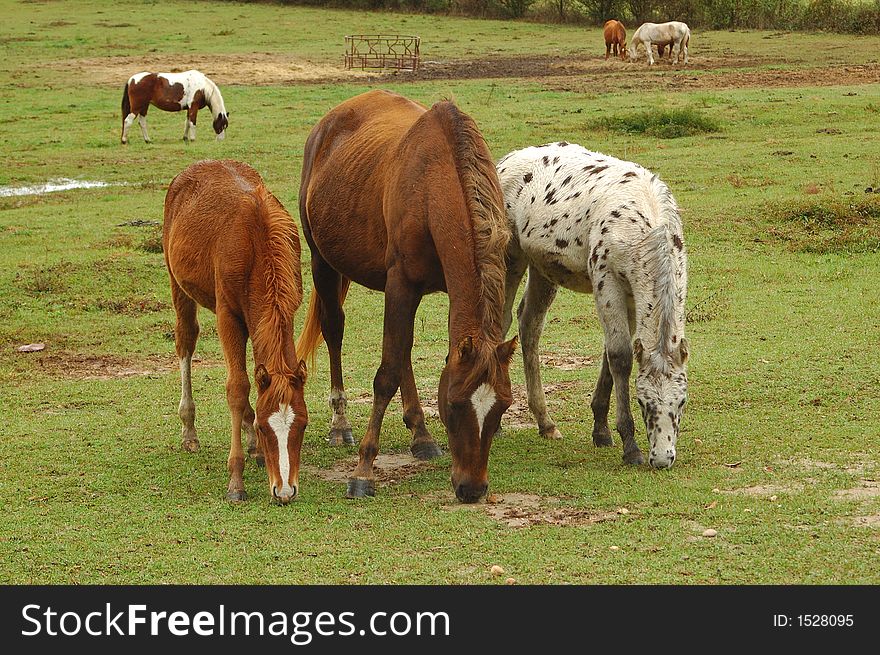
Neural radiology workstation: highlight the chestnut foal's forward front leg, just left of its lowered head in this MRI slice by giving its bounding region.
[217,307,253,501]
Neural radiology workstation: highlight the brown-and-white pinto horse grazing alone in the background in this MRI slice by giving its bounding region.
[122,70,229,143]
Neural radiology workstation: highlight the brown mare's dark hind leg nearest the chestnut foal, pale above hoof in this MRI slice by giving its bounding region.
[312,255,354,446]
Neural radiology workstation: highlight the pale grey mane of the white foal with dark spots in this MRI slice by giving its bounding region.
[636,175,687,374]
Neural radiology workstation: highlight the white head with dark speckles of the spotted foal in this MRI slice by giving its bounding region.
[633,337,688,469]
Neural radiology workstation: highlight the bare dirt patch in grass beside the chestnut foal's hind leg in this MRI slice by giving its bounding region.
[29,352,222,380]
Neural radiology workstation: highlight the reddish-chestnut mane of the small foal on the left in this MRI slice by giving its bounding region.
[253,186,305,405]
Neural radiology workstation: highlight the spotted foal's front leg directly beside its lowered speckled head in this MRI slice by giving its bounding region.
[594,275,645,464]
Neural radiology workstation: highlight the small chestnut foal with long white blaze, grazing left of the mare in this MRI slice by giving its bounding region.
[162,160,308,504]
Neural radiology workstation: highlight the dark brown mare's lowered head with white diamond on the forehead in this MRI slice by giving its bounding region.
[437,337,516,503]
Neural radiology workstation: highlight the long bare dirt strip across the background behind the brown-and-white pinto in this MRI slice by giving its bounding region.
[34,52,880,94]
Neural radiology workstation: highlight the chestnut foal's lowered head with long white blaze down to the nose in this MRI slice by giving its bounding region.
[254,362,309,505]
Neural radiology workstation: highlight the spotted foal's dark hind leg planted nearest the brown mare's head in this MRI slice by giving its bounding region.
[517,266,562,439]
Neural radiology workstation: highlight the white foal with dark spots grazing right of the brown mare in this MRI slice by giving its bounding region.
[498,141,688,468]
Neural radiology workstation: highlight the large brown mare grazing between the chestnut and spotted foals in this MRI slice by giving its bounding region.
[297,91,516,502]
